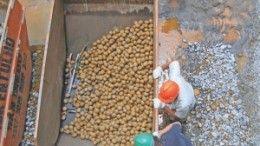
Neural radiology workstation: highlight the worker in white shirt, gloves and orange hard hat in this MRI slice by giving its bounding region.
[153,61,195,122]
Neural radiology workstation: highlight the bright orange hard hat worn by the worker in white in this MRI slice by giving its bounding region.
[159,80,179,103]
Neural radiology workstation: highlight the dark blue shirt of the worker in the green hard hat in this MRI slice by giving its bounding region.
[162,124,192,146]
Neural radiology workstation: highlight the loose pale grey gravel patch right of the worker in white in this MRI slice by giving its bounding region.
[180,43,252,146]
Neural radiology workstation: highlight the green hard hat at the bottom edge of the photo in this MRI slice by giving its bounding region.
[134,133,154,146]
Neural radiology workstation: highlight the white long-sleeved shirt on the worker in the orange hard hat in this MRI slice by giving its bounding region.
[169,61,195,119]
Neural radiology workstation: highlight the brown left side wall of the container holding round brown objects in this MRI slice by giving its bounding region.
[34,0,66,146]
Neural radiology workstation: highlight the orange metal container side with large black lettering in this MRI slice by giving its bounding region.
[0,0,32,146]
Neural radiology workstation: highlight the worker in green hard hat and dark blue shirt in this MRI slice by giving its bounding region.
[134,122,192,146]
